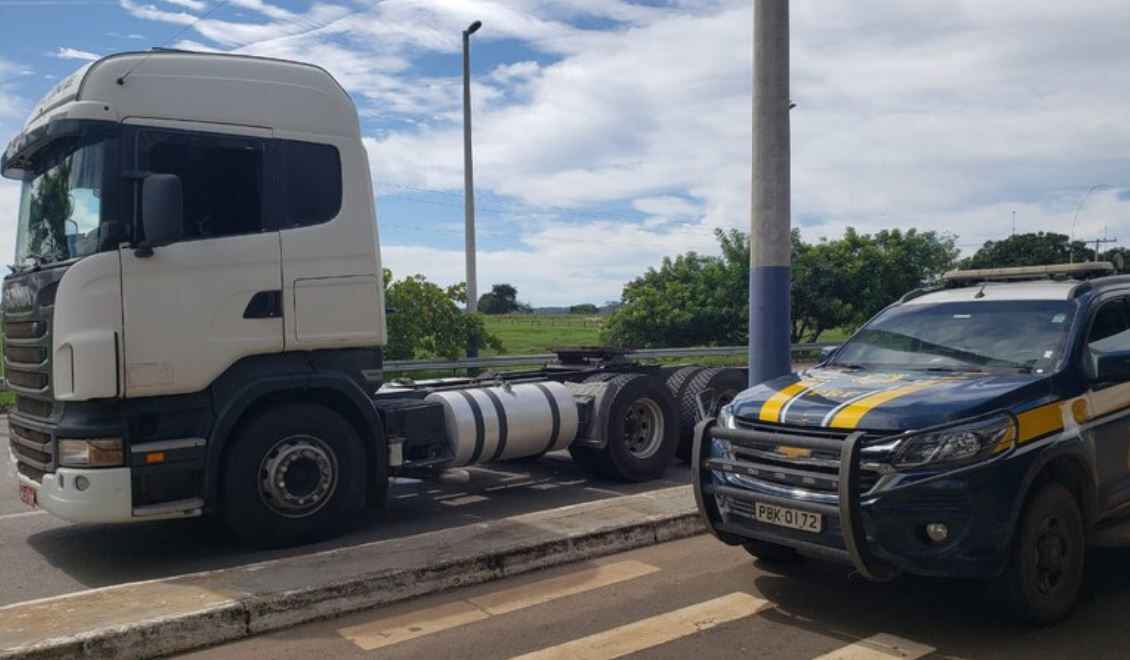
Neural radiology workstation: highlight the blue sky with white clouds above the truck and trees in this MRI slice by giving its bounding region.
[0,0,1130,305]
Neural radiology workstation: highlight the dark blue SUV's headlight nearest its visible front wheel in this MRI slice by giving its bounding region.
[890,413,1016,469]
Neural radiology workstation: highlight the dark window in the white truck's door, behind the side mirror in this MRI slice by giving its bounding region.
[138,131,263,241]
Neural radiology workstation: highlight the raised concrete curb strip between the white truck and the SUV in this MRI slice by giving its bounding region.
[0,486,704,660]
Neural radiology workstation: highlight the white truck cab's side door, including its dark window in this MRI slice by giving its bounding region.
[121,122,283,397]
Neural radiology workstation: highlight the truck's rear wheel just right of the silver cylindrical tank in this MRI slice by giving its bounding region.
[570,374,679,481]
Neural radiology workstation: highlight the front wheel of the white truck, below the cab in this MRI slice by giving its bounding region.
[221,403,365,547]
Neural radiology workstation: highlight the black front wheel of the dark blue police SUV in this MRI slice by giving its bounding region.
[1001,483,1086,625]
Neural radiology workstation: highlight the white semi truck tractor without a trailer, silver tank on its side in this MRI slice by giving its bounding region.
[0,51,745,545]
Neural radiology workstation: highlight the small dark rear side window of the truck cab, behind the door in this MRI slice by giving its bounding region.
[283,140,341,227]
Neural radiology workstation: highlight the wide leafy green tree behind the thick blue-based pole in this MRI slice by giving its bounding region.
[605,228,958,347]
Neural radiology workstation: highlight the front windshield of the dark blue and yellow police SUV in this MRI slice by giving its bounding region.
[831,301,1076,373]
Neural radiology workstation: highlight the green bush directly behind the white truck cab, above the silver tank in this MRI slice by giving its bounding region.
[384,269,503,359]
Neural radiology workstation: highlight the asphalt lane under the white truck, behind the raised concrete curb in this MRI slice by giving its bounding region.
[0,417,689,606]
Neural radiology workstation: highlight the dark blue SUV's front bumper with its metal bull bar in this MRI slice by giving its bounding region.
[692,419,1026,580]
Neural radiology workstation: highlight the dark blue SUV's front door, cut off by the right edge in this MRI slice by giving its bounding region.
[1084,297,1130,511]
